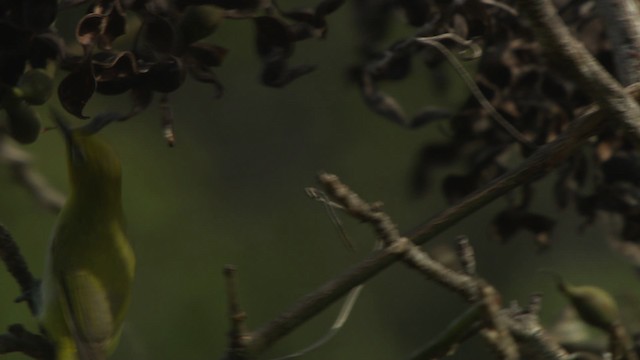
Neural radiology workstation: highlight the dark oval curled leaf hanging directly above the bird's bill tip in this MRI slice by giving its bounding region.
[58,61,96,119]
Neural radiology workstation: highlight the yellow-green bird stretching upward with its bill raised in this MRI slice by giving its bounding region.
[38,116,135,360]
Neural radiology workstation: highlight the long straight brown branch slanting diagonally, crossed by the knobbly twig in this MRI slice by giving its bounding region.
[248,85,640,354]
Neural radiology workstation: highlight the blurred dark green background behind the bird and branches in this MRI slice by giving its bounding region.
[0,6,637,360]
